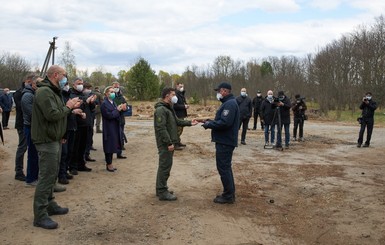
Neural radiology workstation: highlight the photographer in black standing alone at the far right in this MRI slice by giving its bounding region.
[357,92,377,147]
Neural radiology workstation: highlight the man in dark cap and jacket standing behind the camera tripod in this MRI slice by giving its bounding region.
[276,91,291,148]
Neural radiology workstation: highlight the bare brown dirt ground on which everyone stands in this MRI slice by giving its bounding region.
[0,104,385,245]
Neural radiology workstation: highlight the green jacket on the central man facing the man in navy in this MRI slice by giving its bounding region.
[154,101,191,147]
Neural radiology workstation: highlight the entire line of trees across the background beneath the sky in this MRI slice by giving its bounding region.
[0,16,385,116]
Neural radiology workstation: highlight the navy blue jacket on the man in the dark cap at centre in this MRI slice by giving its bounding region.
[207,94,239,147]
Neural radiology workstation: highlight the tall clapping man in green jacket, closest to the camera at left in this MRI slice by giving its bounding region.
[31,65,81,229]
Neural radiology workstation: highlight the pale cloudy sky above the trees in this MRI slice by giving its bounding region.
[0,0,385,74]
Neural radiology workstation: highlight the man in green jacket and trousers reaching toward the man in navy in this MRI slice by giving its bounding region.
[154,88,198,201]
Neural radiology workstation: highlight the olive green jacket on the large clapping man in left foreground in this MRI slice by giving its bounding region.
[31,77,71,144]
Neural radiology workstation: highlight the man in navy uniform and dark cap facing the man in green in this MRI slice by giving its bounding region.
[202,82,239,204]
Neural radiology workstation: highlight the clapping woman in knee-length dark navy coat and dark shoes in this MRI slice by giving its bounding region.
[100,86,126,172]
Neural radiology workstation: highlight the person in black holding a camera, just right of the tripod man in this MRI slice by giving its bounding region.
[291,94,307,141]
